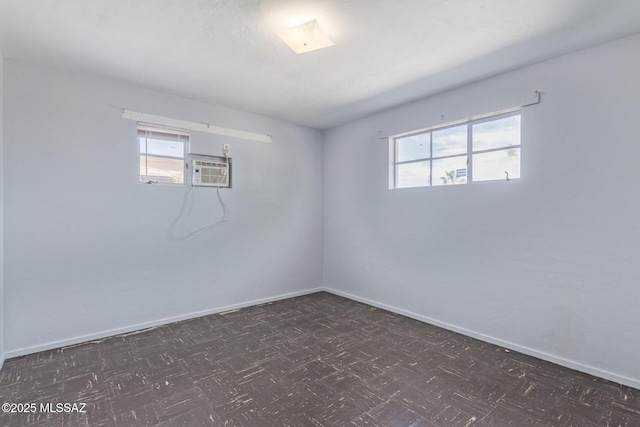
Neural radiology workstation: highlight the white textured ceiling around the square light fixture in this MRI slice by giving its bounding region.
[0,0,640,129]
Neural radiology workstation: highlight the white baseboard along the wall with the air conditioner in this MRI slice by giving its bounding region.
[5,288,324,367]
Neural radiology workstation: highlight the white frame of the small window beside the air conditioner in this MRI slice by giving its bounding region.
[136,122,191,187]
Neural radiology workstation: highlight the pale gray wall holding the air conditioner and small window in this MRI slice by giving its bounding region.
[4,59,323,356]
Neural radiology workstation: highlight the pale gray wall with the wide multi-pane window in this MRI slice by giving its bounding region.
[324,35,640,387]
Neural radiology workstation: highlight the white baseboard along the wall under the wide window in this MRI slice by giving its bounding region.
[323,287,640,389]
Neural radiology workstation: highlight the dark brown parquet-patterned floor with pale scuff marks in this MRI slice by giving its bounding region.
[0,292,640,427]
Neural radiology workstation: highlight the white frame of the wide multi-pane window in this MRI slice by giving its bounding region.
[389,108,522,190]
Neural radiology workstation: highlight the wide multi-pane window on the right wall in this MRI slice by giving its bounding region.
[391,111,520,188]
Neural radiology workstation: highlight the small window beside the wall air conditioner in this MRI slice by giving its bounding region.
[138,124,189,185]
